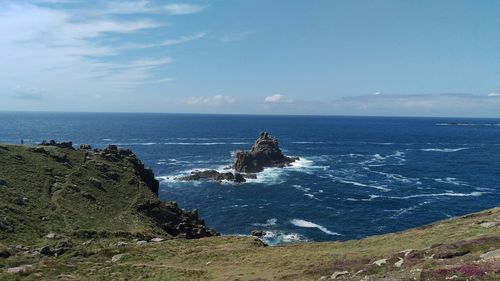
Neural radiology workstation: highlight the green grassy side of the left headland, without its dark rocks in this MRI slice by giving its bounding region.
[0,143,161,245]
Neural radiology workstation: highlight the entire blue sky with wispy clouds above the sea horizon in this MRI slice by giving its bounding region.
[0,0,500,117]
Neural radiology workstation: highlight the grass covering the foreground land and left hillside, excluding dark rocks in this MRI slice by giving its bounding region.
[0,143,500,280]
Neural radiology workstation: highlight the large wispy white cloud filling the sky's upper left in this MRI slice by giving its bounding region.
[0,1,182,98]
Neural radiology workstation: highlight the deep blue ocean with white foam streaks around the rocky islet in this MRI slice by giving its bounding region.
[0,112,500,244]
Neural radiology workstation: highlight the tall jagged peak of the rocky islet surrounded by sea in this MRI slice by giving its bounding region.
[233,132,298,173]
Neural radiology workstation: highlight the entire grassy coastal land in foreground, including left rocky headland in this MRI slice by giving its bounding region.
[0,142,500,281]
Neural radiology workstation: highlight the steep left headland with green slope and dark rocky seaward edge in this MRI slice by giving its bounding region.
[0,142,218,244]
